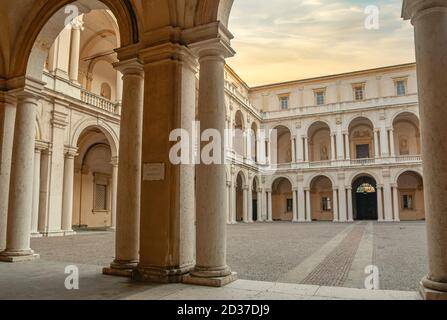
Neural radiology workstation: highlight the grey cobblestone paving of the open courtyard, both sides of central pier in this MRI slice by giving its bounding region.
[27,222,427,290]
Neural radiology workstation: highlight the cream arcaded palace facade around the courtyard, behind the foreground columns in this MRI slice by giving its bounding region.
[11,10,425,236]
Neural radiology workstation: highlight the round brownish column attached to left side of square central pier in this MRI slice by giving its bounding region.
[103,59,144,276]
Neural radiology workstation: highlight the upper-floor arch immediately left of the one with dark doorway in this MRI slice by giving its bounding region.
[308,122,333,162]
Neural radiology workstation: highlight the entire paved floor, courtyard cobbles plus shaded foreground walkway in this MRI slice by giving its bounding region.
[0,222,427,300]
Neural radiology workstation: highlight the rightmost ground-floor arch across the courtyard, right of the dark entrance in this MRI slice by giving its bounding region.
[397,171,425,221]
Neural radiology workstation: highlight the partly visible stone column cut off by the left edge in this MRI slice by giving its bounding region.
[0,92,16,252]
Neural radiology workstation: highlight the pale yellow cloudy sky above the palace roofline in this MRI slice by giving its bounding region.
[228,0,415,86]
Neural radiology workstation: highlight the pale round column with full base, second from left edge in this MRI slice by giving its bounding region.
[0,92,39,262]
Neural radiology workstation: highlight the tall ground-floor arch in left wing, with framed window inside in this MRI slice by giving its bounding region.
[73,127,114,229]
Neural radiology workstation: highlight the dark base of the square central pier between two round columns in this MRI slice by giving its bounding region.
[132,265,194,283]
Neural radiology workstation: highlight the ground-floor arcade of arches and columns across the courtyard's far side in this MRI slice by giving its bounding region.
[227,165,425,224]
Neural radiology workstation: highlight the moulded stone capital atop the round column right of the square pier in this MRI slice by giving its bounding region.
[183,22,236,59]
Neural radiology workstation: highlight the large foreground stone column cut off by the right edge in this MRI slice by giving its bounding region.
[403,0,447,300]
